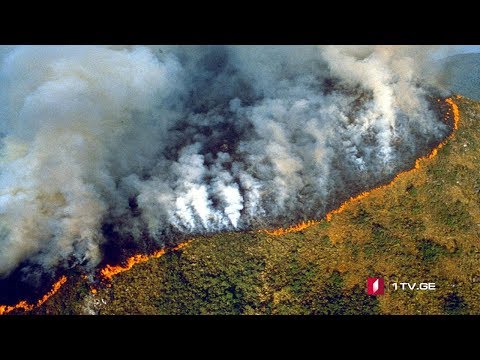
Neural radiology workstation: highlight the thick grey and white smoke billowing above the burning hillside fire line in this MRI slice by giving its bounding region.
[0,46,448,276]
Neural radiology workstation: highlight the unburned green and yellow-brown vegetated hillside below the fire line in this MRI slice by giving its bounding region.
[36,99,480,314]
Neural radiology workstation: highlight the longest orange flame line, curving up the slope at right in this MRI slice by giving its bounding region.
[260,95,461,236]
